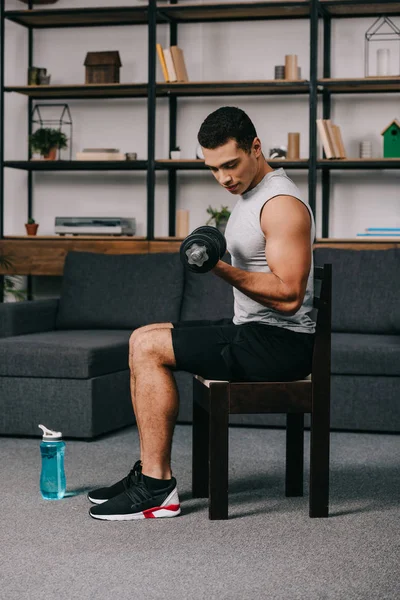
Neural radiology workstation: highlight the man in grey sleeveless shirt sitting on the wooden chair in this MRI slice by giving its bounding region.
[88,107,315,520]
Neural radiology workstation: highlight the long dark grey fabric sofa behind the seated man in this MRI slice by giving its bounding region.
[0,248,400,439]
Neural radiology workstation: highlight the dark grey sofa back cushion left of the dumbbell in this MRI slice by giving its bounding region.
[56,252,183,330]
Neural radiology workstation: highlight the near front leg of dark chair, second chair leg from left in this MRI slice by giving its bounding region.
[208,383,229,520]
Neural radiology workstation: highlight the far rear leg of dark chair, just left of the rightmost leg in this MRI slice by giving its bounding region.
[285,413,304,496]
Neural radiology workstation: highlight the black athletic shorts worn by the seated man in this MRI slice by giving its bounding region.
[171,319,315,381]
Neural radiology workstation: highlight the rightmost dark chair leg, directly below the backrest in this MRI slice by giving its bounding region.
[310,403,330,518]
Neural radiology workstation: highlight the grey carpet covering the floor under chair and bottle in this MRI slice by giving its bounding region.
[0,423,400,600]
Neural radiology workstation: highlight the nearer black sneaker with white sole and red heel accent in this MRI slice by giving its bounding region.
[89,463,181,521]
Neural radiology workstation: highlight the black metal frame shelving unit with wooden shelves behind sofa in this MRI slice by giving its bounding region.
[0,0,400,286]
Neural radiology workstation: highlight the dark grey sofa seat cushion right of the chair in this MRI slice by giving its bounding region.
[331,333,400,376]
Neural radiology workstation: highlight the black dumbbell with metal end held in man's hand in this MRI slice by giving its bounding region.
[180,225,226,273]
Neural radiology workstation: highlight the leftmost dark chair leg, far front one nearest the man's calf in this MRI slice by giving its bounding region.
[192,378,209,498]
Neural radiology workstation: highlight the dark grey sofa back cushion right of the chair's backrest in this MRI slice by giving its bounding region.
[314,248,400,334]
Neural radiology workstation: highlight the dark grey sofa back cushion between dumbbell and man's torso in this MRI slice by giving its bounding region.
[180,254,233,321]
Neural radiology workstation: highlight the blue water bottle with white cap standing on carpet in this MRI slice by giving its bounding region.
[39,425,66,500]
